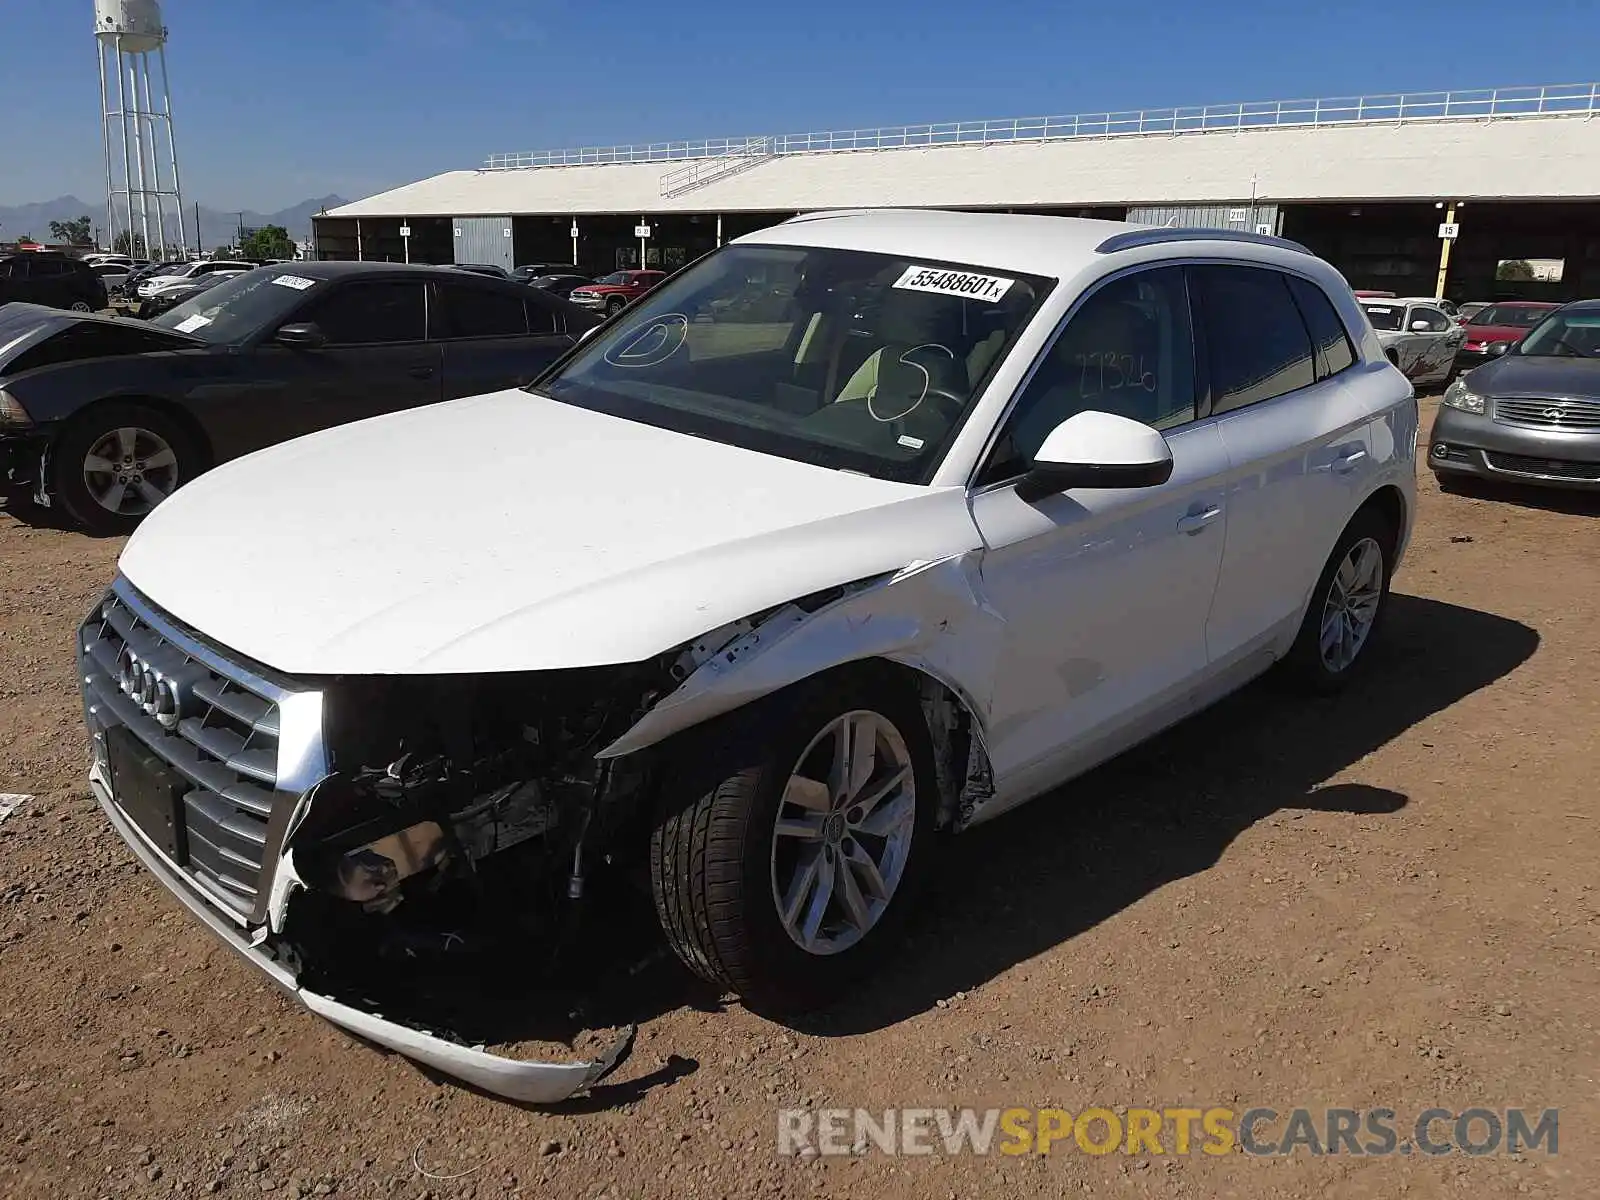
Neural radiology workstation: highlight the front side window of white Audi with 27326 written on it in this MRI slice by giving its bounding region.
[978,267,1195,485]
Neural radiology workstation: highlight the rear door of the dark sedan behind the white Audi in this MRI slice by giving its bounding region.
[429,280,573,400]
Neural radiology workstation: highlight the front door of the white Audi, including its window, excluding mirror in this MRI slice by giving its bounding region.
[973,267,1227,806]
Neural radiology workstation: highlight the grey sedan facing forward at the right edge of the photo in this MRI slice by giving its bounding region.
[1427,301,1600,491]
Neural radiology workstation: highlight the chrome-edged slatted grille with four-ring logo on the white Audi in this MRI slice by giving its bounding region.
[78,581,320,920]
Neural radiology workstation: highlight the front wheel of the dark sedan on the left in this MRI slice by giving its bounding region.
[51,403,195,534]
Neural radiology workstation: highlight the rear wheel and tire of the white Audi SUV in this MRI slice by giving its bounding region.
[1283,507,1397,693]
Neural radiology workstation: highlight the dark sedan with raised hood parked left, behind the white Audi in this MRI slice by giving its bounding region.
[0,262,598,533]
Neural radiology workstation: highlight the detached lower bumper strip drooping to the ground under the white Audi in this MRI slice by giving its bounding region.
[90,763,634,1104]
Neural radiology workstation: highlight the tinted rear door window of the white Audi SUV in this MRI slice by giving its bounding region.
[1192,267,1317,413]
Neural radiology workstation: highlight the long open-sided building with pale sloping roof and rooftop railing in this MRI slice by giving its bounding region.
[315,83,1600,299]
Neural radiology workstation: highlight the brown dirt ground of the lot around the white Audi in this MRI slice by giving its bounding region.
[0,403,1600,1200]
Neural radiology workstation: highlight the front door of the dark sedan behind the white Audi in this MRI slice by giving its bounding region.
[236,278,443,445]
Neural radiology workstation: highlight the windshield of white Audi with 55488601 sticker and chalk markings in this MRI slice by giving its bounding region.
[538,245,1051,483]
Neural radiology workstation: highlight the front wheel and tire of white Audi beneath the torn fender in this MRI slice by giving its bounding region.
[651,669,938,1011]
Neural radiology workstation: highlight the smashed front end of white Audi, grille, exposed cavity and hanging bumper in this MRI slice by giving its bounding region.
[78,579,674,1104]
